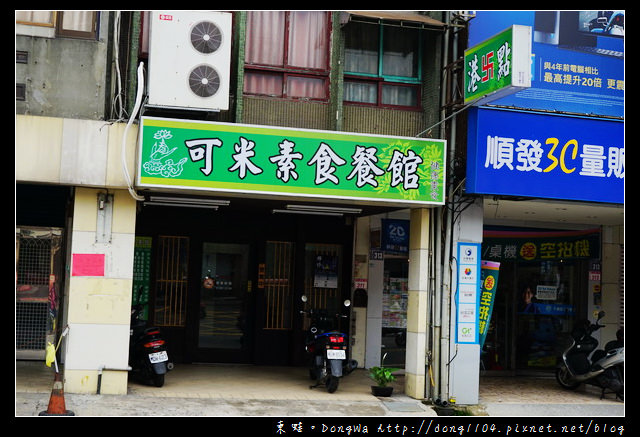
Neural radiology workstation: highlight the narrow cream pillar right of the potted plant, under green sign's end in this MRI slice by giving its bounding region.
[404,209,431,399]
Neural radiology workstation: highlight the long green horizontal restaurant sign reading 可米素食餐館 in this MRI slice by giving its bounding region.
[137,117,446,205]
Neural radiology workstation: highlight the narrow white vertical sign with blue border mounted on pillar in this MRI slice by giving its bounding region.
[456,243,480,343]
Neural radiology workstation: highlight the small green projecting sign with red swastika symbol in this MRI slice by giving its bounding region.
[464,25,531,105]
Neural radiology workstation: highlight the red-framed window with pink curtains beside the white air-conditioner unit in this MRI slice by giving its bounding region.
[244,11,330,100]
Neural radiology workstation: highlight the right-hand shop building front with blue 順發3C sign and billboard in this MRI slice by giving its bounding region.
[444,11,625,406]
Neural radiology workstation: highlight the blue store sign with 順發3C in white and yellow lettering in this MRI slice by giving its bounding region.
[466,108,624,204]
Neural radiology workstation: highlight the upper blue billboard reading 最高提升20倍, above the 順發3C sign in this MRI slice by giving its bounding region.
[469,11,625,117]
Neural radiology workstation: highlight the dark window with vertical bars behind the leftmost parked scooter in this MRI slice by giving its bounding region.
[153,236,189,326]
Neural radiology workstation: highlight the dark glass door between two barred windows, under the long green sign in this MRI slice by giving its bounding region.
[197,243,251,361]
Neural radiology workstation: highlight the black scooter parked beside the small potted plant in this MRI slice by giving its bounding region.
[300,296,358,393]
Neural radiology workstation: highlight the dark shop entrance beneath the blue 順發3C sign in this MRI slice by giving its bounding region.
[481,227,599,374]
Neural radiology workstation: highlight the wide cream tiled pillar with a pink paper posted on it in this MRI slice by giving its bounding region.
[63,188,136,394]
